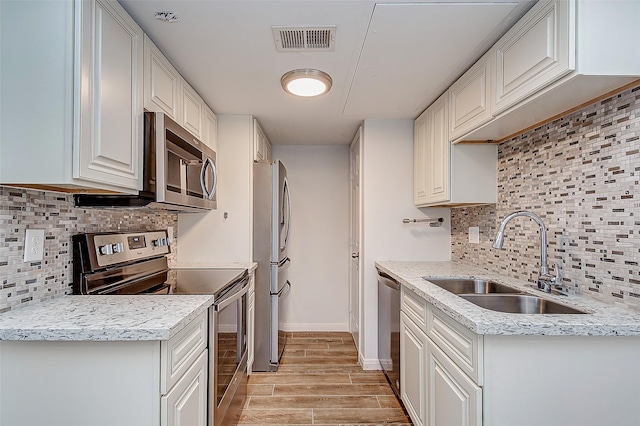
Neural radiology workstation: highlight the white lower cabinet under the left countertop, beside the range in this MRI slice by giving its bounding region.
[0,312,209,426]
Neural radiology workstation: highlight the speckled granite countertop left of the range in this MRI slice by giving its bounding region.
[0,295,214,341]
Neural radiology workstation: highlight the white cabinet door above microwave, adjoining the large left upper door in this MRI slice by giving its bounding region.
[144,35,182,123]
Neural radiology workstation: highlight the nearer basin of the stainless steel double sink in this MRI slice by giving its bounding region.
[460,294,586,314]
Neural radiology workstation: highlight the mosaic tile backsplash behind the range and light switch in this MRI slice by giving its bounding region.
[0,186,178,313]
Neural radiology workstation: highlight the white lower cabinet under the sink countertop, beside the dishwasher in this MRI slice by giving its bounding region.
[400,287,640,426]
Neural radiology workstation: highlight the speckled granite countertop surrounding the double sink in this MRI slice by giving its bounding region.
[375,261,640,336]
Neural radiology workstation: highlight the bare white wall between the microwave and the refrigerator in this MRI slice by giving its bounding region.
[177,115,253,265]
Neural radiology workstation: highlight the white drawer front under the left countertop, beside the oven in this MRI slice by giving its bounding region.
[160,311,207,395]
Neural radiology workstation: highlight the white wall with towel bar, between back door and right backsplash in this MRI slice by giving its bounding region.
[360,119,451,368]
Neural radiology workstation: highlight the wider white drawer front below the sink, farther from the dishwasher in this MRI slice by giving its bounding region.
[427,306,483,386]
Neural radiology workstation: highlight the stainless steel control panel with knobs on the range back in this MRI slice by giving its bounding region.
[87,231,170,267]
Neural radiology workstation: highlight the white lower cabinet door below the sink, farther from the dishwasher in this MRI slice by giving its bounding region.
[427,340,482,426]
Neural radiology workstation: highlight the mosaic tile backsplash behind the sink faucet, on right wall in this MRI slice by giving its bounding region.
[451,87,640,310]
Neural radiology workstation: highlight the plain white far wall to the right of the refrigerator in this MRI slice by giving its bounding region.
[273,145,349,331]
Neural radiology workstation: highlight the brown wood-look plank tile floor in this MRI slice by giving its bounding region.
[240,332,411,426]
